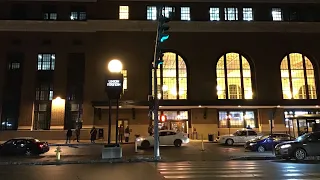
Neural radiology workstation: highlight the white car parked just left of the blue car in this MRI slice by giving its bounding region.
[217,129,261,146]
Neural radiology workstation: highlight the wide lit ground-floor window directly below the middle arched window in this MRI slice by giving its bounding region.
[219,110,257,128]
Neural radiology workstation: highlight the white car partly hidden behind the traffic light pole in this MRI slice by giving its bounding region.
[136,130,190,148]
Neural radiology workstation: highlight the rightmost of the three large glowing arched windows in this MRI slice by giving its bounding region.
[280,53,317,99]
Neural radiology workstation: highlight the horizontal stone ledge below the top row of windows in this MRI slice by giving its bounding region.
[0,20,320,33]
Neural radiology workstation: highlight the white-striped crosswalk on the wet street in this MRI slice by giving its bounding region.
[155,162,320,180]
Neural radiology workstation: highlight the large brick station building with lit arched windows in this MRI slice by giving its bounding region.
[0,0,320,139]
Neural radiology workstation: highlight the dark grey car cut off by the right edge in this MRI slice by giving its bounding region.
[275,132,320,160]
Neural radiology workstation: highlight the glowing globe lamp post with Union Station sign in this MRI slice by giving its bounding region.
[107,59,123,144]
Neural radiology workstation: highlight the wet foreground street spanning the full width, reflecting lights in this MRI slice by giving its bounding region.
[0,161,320,180]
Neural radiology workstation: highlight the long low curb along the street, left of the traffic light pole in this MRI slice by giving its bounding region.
[0,158,162,166]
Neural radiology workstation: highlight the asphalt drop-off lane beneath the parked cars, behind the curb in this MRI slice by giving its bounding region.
[0,142,271,162]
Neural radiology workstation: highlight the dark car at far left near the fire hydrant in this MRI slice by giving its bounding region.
[0,137,50,156]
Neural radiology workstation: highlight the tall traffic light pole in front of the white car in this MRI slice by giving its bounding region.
[153,7,162,160]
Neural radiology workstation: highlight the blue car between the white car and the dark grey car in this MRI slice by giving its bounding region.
[244,133,295,152]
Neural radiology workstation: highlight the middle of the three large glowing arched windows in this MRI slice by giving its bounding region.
[216,53,253,99]
